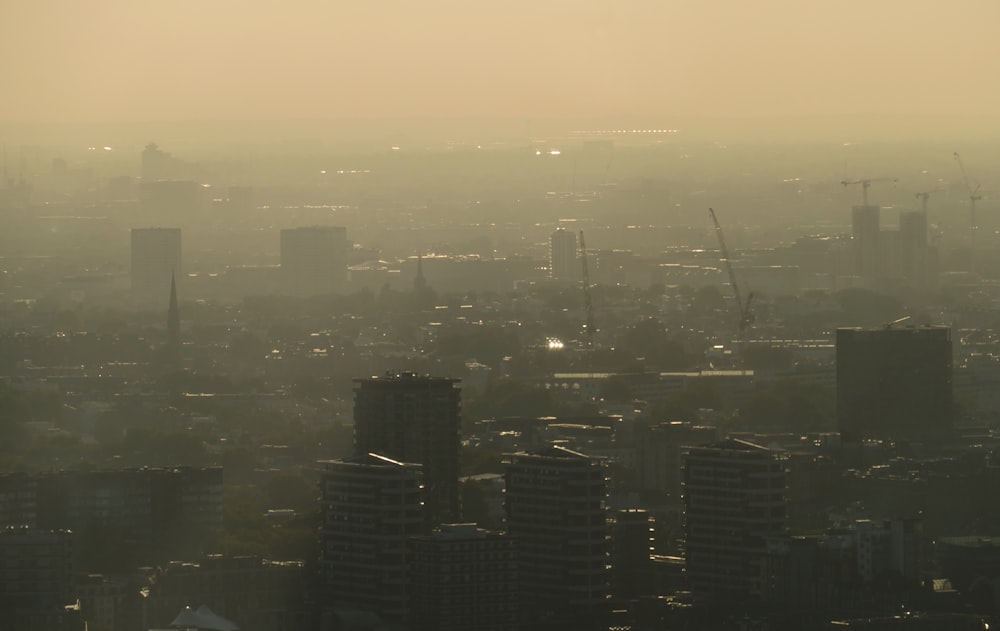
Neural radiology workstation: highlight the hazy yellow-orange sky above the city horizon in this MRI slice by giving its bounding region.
[0,0,1000,122]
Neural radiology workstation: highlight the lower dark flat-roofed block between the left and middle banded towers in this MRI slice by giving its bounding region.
[410,524,519,631]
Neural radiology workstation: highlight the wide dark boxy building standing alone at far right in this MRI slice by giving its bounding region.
[837,326,954,442]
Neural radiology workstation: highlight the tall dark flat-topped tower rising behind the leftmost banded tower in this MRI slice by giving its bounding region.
[354,372,461,526]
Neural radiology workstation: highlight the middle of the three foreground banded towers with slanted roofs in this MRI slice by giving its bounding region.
[504,445,610,628]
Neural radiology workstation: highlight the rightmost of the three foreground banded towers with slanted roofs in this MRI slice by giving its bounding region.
[684,439,786,602]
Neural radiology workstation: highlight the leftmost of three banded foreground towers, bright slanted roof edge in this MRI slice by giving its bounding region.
[320,454,425,622]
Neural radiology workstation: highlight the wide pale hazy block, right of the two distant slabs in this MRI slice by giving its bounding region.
[281,226,349,296]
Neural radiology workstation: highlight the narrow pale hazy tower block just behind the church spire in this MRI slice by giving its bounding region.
[131,228,183,308]
